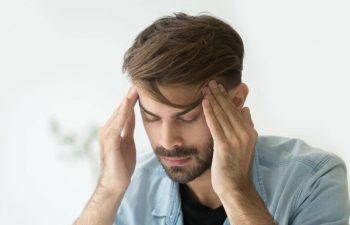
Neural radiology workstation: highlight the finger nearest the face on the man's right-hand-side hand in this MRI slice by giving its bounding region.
[202,98,225,142]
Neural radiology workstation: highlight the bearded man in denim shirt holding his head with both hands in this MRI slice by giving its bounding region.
[76,13,349,225]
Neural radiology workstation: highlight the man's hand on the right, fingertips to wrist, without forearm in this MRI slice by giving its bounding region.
[203,80,258,196]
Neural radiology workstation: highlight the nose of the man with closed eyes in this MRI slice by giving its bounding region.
[159,123,183,150]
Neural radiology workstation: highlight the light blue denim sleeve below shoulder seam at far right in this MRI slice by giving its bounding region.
[289,155,350,225]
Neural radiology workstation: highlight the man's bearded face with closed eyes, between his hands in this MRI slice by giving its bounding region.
[137,83,213,183]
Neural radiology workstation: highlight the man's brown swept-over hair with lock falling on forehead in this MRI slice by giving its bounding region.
[123,13,244,108]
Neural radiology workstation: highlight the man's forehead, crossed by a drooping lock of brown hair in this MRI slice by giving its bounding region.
[136,85,203,112]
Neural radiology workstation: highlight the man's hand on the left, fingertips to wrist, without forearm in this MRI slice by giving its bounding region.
[98,87,138,194]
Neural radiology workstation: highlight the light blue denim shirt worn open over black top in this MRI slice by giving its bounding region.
[115,136,350,225]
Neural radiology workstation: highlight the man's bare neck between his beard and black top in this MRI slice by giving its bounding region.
[186,168,222,209]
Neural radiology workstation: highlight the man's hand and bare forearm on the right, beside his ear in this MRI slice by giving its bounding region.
[203,81,275,225]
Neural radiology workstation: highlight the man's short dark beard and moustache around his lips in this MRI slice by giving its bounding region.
[154,138,214,183]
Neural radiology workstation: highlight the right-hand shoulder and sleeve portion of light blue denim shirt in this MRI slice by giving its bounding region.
[254,136,349,224]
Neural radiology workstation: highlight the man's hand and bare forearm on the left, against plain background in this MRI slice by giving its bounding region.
[74,87,138,225]
